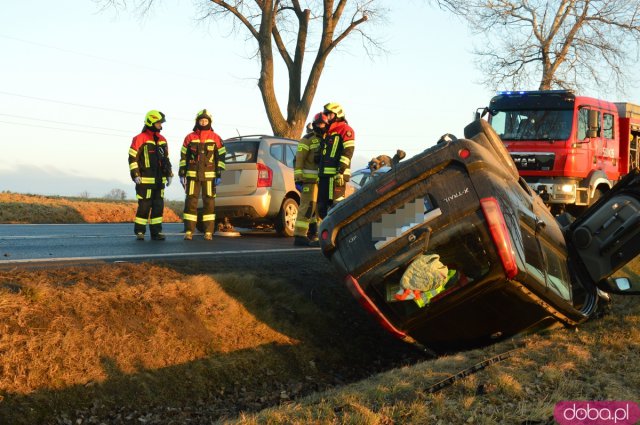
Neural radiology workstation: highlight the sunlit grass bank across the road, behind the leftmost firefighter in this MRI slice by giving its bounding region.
[0,192,183,224]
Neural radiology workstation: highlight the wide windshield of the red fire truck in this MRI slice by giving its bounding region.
[491,110,573,141]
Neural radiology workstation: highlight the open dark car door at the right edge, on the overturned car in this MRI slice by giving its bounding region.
[566,169,640,293]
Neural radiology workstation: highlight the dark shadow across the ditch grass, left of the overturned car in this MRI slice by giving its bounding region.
[0,250,428,424]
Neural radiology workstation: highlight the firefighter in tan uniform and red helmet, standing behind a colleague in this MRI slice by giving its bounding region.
[293,112,329,246]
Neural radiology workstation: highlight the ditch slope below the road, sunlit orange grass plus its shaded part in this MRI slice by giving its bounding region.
[0,258,420,424]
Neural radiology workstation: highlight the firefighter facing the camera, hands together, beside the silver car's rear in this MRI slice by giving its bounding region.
[178,109,227,241]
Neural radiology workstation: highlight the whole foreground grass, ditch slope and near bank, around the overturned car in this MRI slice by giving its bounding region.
[0,253,640,424]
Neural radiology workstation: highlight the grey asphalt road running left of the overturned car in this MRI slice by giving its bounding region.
[0,223,319,267]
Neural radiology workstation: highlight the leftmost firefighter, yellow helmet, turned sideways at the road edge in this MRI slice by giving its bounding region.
[129,110,173,241]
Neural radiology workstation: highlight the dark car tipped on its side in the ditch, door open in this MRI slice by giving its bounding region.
[320,120,640,352]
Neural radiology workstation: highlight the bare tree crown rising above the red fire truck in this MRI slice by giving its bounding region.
[437,0,640,90]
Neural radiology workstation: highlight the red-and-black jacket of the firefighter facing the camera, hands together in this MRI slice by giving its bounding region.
[178,130,227,181]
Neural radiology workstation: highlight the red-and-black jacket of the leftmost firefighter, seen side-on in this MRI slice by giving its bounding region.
[129,128,173,189]
